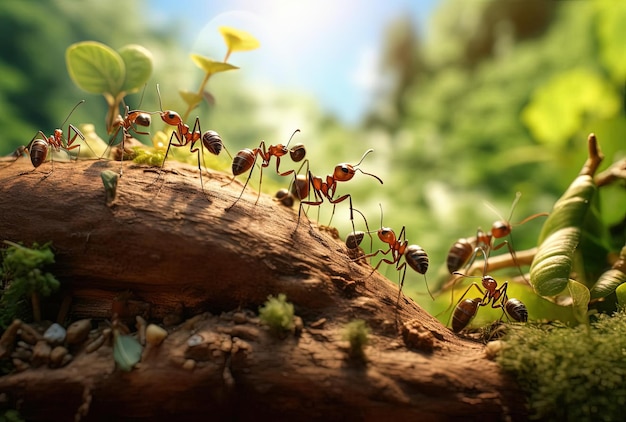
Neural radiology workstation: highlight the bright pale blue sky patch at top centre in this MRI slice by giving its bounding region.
[149,0,437,123]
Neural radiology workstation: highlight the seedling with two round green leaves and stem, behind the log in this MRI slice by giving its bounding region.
[65,41,152,134]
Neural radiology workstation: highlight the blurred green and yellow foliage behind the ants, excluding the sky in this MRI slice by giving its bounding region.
[0,0,626,321]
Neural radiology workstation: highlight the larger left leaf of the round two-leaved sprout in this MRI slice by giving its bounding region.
[65,41,126,97]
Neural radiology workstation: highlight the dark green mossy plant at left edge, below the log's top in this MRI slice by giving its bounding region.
[0,240,60,328]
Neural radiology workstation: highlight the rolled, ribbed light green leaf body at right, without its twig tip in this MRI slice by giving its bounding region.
[530,175,596,296]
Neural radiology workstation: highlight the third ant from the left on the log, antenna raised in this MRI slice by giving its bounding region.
[155,84,230,199]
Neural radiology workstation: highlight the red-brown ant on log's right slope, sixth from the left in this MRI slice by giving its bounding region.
[354,206,435,316]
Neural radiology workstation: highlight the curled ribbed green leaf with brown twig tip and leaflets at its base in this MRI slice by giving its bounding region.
[530,134,623,322]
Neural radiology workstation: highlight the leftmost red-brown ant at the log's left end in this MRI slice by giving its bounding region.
[9,100,85,179]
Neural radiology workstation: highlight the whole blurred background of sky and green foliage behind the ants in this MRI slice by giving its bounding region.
[0,0,626,322]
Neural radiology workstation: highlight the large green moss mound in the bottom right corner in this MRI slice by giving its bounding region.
[498,311,626,421]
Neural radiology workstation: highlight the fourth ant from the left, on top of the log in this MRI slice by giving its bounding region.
[226,129,306,211]
